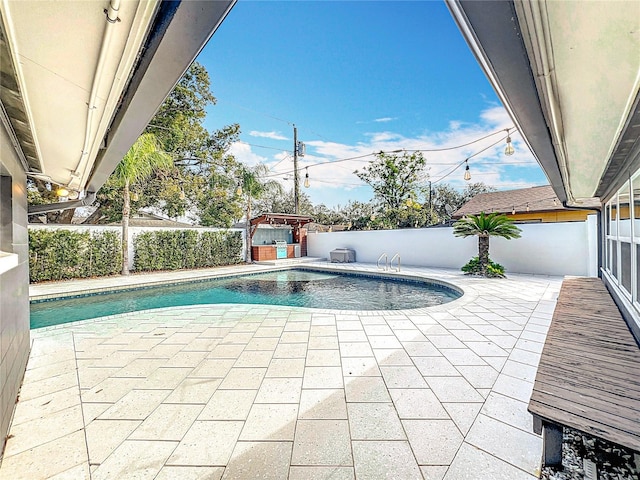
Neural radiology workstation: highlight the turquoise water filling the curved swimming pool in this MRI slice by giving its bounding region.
[31,270,460,328]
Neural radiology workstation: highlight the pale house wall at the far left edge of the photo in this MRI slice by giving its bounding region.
[0,122,29,451]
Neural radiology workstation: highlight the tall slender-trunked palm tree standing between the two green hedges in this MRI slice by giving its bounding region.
[113,133,173,275]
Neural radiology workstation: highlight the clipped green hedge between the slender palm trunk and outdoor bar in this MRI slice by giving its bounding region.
[133,230,242,272]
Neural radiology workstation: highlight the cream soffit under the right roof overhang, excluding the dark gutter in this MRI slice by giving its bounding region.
[515,1,640,199]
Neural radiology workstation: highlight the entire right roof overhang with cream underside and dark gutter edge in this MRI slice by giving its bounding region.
[447,0,640,206]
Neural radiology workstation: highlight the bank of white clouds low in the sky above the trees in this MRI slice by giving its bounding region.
[234,105,546,206]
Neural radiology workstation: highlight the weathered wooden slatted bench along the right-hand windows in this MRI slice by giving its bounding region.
[529,278,640,465]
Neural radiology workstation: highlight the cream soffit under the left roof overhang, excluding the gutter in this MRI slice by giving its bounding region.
[1,0,158,189]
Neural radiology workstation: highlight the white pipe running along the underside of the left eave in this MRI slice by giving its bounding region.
[69,0,120,191]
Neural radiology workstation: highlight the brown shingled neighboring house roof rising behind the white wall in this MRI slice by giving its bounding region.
[453,185,600,218]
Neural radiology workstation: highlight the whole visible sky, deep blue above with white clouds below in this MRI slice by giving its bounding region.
[198,0,547,206]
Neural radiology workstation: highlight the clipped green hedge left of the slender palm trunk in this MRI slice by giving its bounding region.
[29,229,122,283]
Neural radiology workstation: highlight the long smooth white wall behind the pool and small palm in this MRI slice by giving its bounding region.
[307,215,597,276]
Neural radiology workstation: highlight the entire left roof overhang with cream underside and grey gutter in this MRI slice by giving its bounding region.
[0,0,235,209]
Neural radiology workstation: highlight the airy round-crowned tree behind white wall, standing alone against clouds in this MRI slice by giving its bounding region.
[354,152,426,228]
